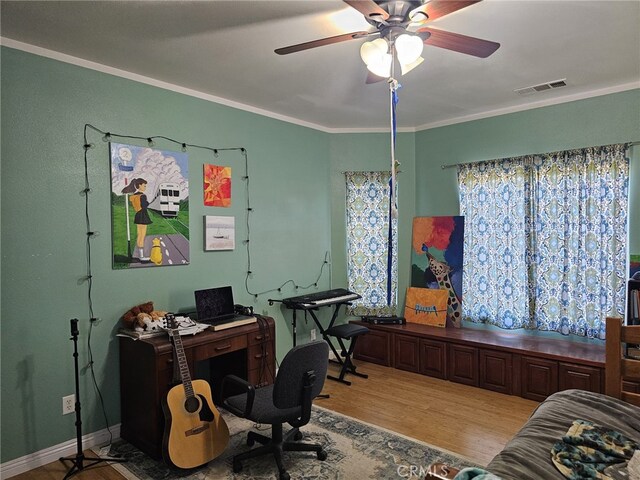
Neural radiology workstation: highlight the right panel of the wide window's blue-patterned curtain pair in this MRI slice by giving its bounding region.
[531,145,629,338]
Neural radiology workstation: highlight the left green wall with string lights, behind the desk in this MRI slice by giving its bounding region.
[1,48,340,462]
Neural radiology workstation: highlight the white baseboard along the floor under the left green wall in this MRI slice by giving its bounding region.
[0,424,120,478]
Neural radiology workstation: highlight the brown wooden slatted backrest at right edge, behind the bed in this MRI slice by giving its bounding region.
[605,318,640,406]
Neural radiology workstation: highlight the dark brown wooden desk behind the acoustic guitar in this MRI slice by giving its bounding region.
[120,317,275,459]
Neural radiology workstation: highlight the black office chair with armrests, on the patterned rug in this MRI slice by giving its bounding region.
[221,340,329,480]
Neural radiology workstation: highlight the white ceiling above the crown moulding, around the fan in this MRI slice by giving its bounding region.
[0,0,640,131]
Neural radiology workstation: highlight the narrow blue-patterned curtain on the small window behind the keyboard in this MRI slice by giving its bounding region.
[345,172,398,315]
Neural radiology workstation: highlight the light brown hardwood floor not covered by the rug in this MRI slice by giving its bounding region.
[13,362,538,480]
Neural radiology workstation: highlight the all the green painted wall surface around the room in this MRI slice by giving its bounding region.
[0,47,640,463]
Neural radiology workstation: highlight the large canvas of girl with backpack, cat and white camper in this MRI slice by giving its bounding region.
[109,143,189,269]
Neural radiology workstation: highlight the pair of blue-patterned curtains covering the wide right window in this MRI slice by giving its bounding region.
[458,145,629,338]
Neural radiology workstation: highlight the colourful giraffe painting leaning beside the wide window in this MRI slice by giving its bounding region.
[411,216,464,327]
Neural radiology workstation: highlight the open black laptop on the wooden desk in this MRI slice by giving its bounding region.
[194,286,256,330]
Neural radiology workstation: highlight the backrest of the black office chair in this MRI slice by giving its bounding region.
[273,340,329,408]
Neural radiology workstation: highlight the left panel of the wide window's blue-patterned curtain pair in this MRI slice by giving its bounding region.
[458,157,532,328]
